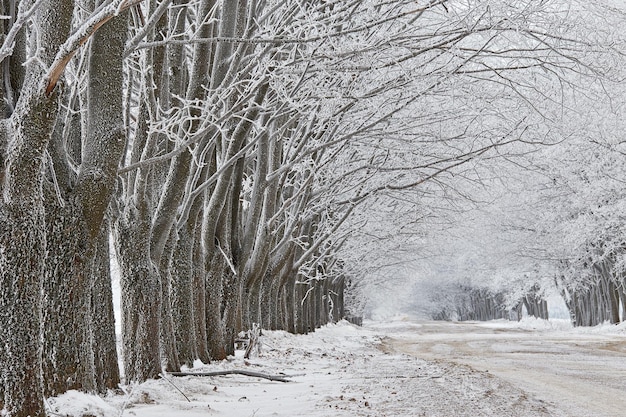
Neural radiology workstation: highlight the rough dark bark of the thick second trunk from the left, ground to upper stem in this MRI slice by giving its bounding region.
[44,0,127,396]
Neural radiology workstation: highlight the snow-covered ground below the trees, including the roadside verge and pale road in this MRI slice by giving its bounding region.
[48,318,626,417]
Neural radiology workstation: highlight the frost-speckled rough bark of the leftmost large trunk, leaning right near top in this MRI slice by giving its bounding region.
[0,1,73,410]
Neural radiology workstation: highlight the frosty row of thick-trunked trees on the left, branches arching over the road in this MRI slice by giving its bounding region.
[0,0,608,417]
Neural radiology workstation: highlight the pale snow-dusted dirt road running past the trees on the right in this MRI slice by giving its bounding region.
[372,322,626,417]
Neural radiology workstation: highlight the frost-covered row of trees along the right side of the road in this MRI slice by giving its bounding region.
[410,0,626,326]
